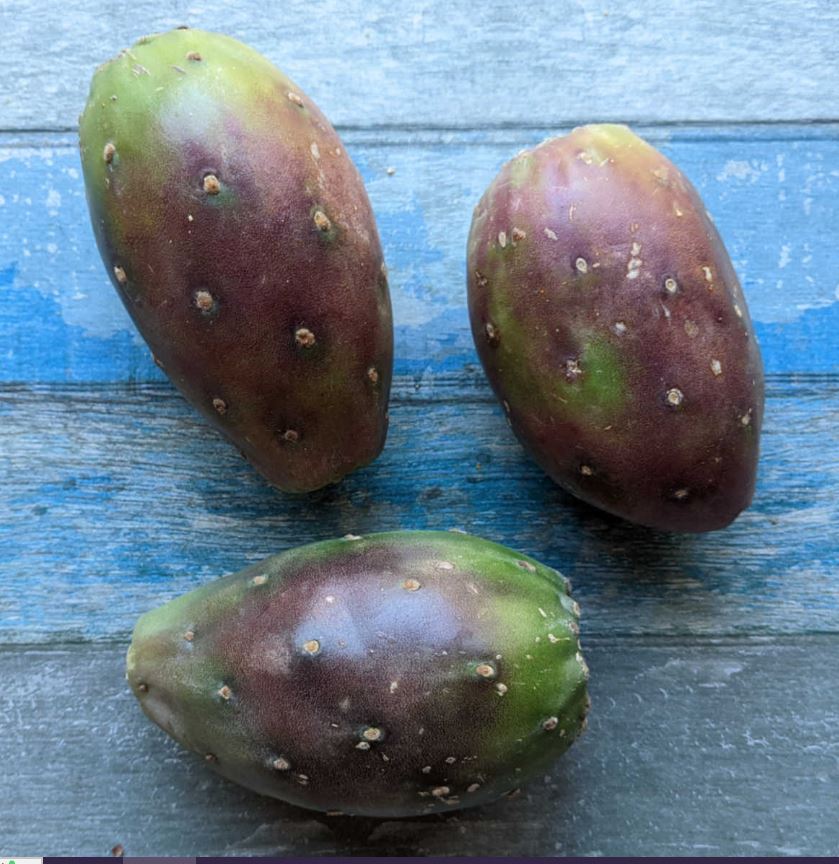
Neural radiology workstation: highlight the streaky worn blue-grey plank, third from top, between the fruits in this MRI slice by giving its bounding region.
[0,375,839,642]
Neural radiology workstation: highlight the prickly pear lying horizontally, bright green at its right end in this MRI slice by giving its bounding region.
[127,531,589,816]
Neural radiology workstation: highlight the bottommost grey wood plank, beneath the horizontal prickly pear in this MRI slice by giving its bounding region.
[0,637,839,857]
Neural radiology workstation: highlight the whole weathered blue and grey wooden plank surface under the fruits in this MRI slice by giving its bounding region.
[0,0,839,856]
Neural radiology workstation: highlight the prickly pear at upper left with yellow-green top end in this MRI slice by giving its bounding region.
[79,29,393,492]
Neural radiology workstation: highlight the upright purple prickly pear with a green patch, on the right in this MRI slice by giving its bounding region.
[468,125,764,531]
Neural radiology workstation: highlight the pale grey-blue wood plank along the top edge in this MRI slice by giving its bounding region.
[0,0,839,129]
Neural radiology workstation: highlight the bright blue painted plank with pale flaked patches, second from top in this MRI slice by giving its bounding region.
[0,126,839,383]
